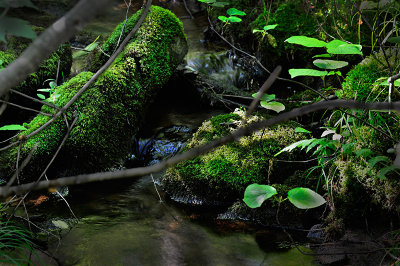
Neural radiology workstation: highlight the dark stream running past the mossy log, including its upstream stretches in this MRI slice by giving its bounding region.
[27,1,313,265]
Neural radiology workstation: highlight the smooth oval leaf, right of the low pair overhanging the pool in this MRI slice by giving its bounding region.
[288,187,326,209]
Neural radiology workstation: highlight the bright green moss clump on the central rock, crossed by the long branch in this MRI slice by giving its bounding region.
[163,110,302,201]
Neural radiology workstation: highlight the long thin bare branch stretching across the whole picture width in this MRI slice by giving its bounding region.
[0,100,400,197]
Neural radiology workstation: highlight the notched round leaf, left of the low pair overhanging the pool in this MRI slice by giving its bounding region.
[243,184,277,208]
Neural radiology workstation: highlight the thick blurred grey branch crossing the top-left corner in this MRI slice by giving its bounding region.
[0,0,110,96]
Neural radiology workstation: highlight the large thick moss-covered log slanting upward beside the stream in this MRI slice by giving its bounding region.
[0,6,187,180]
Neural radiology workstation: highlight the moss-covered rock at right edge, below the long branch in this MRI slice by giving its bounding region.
[332,126,400,220]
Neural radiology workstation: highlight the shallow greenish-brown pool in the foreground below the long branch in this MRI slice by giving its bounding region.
[43,176,312,265]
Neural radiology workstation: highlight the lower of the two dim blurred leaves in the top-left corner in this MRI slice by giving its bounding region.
[0,17,36,42]
